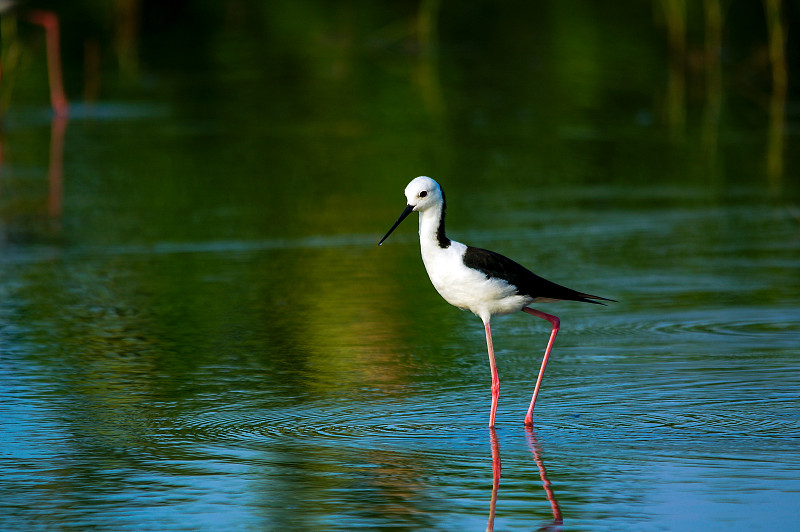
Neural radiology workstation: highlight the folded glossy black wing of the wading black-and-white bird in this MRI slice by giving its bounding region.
[464,246,614,305]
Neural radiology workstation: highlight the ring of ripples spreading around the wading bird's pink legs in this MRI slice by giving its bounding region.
[171,375,800,456]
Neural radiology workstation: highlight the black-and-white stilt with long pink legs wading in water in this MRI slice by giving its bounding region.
[378,176,616,428]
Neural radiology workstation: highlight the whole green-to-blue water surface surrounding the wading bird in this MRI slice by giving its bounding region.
[0,2,800,530]
